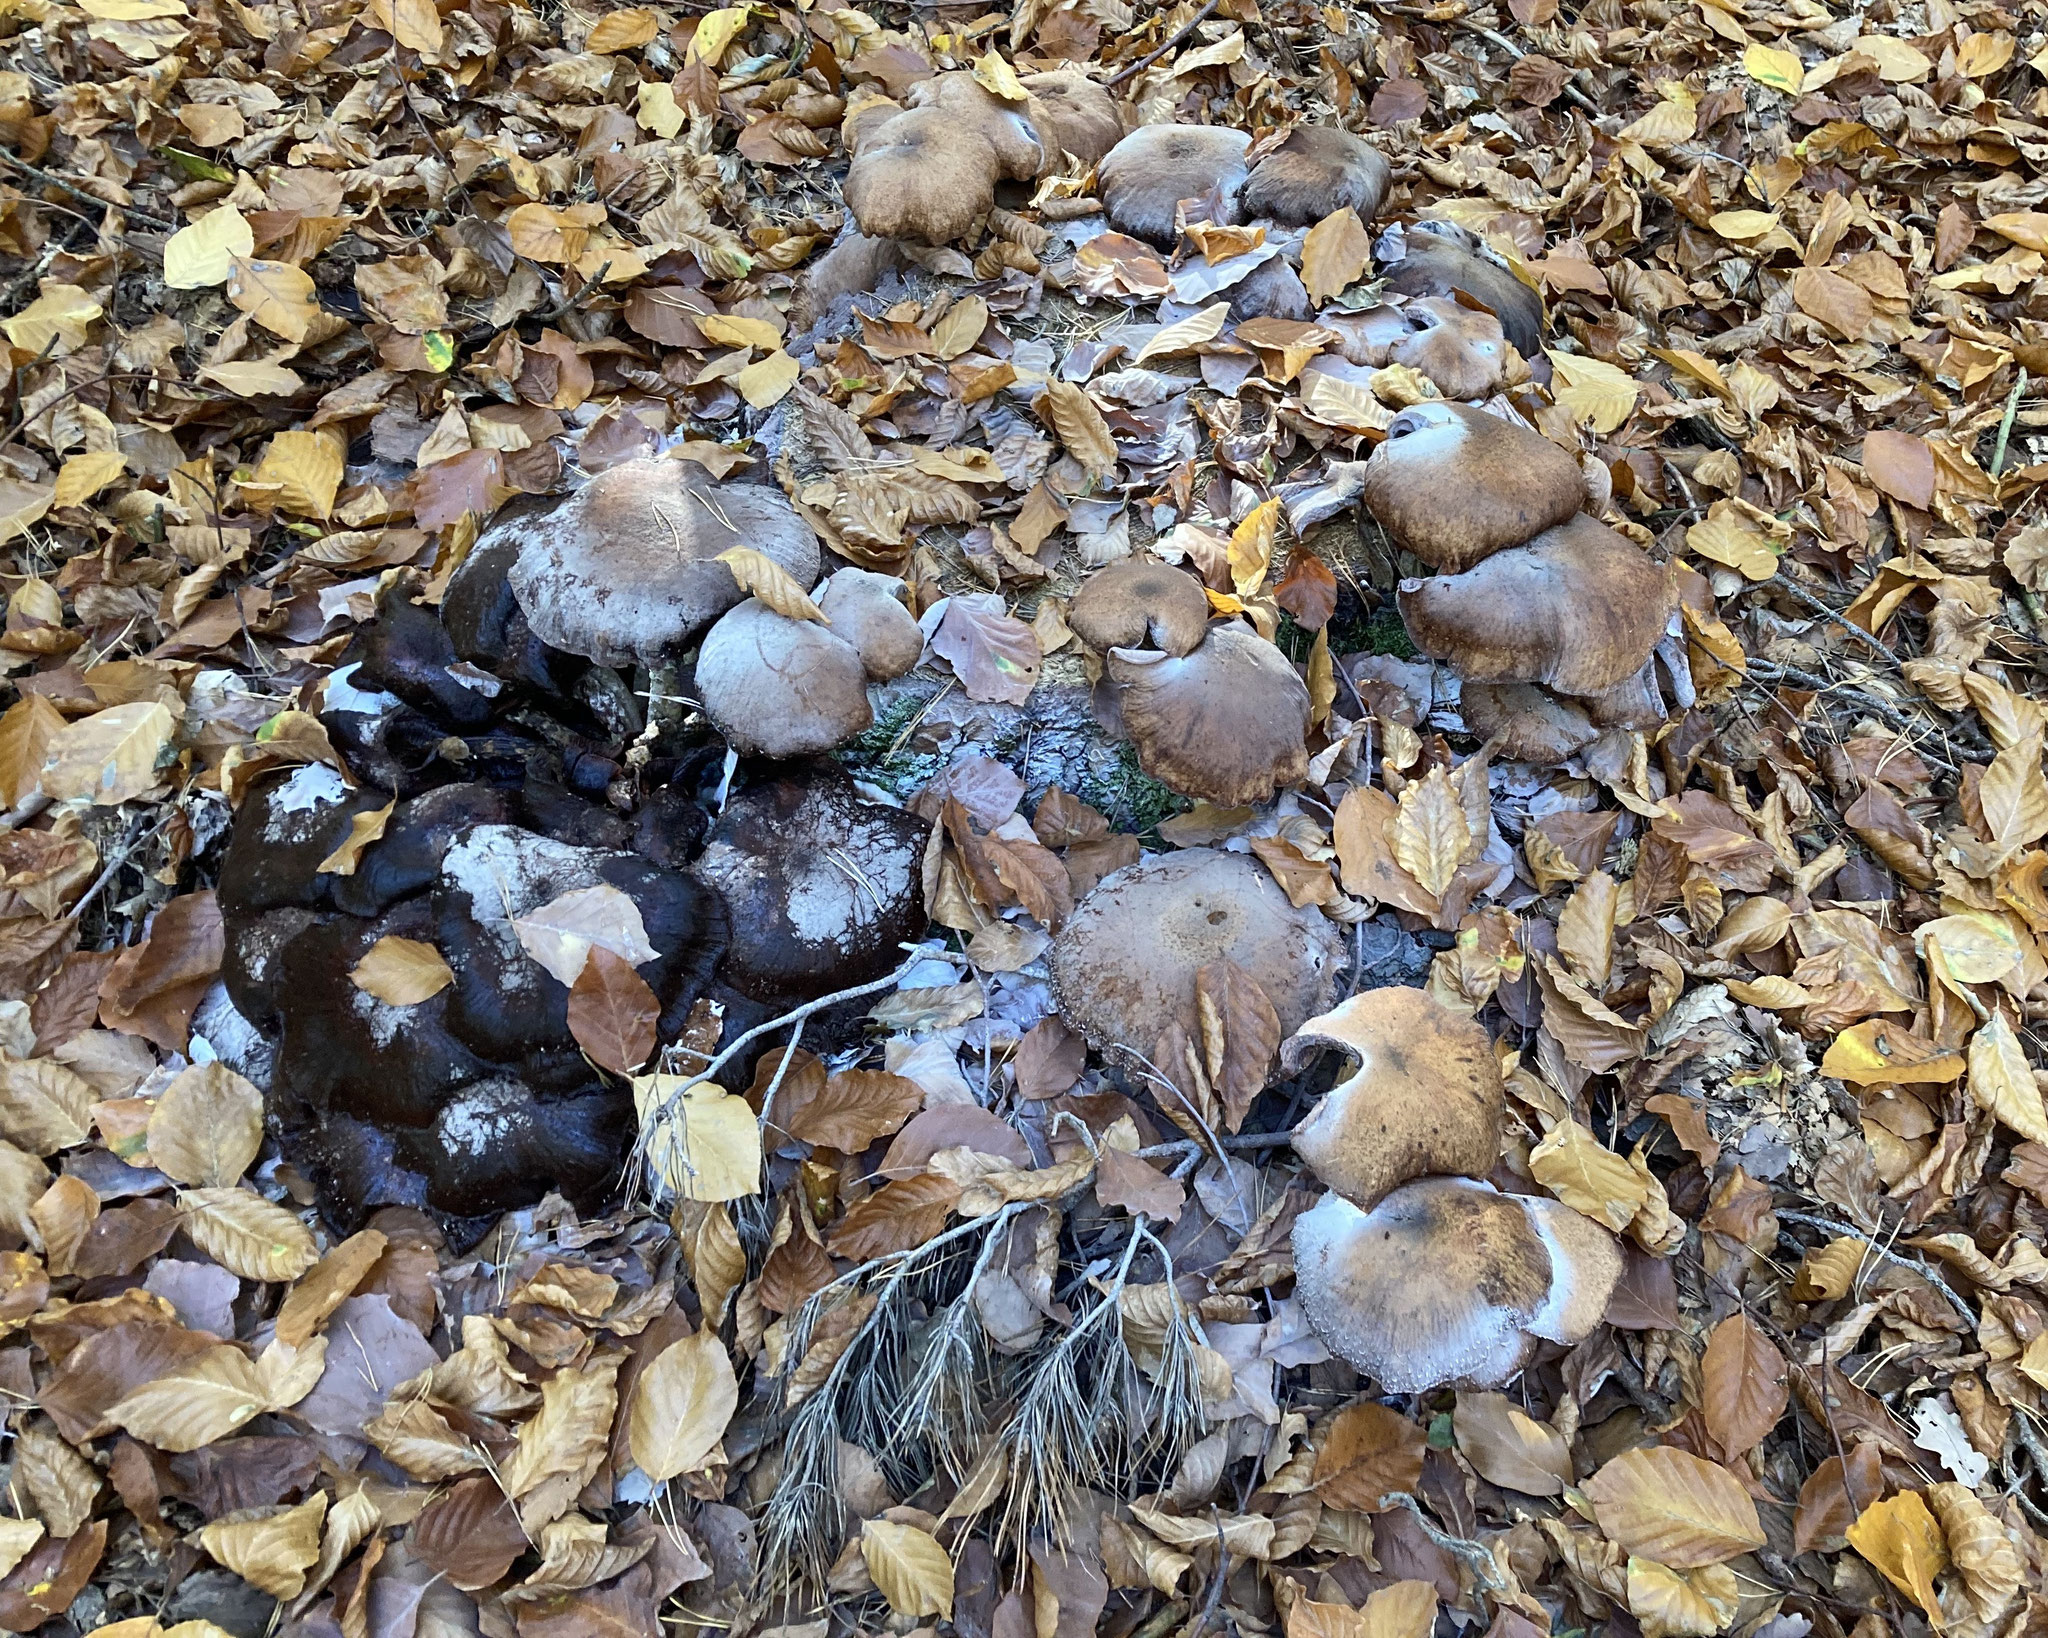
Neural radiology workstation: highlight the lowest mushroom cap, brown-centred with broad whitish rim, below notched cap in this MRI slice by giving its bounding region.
[1294,1177,1550,1392]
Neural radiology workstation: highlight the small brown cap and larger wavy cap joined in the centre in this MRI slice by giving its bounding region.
[1067,557,1311,807]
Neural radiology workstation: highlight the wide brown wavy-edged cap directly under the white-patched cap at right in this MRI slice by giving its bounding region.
[1397,514,1677,694]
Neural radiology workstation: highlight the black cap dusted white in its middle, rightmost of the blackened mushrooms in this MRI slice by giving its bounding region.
[692,762,926,1009]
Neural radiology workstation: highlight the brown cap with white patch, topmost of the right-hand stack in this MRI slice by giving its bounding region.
[1360,403,1585,573]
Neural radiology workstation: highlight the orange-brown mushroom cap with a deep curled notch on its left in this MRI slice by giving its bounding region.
[1280,985,1505,1206]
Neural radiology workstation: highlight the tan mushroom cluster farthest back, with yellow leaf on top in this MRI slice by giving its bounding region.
[844,70,1124,244]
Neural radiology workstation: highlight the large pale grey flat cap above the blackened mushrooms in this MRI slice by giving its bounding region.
[493,461,819,665]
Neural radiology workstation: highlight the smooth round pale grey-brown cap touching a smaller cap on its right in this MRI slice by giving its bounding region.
[696,598,874,756]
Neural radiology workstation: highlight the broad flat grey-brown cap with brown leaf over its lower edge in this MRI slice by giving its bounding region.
[1049,848,1343,1063]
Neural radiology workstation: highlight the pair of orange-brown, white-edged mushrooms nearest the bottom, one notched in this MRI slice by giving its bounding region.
[1282,987,1624,1392]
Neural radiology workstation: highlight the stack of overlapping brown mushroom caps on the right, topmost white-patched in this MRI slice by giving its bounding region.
[1360,403,1686,762]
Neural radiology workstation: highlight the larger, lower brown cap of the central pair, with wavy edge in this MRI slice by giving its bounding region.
[1108,624,1311,807]
